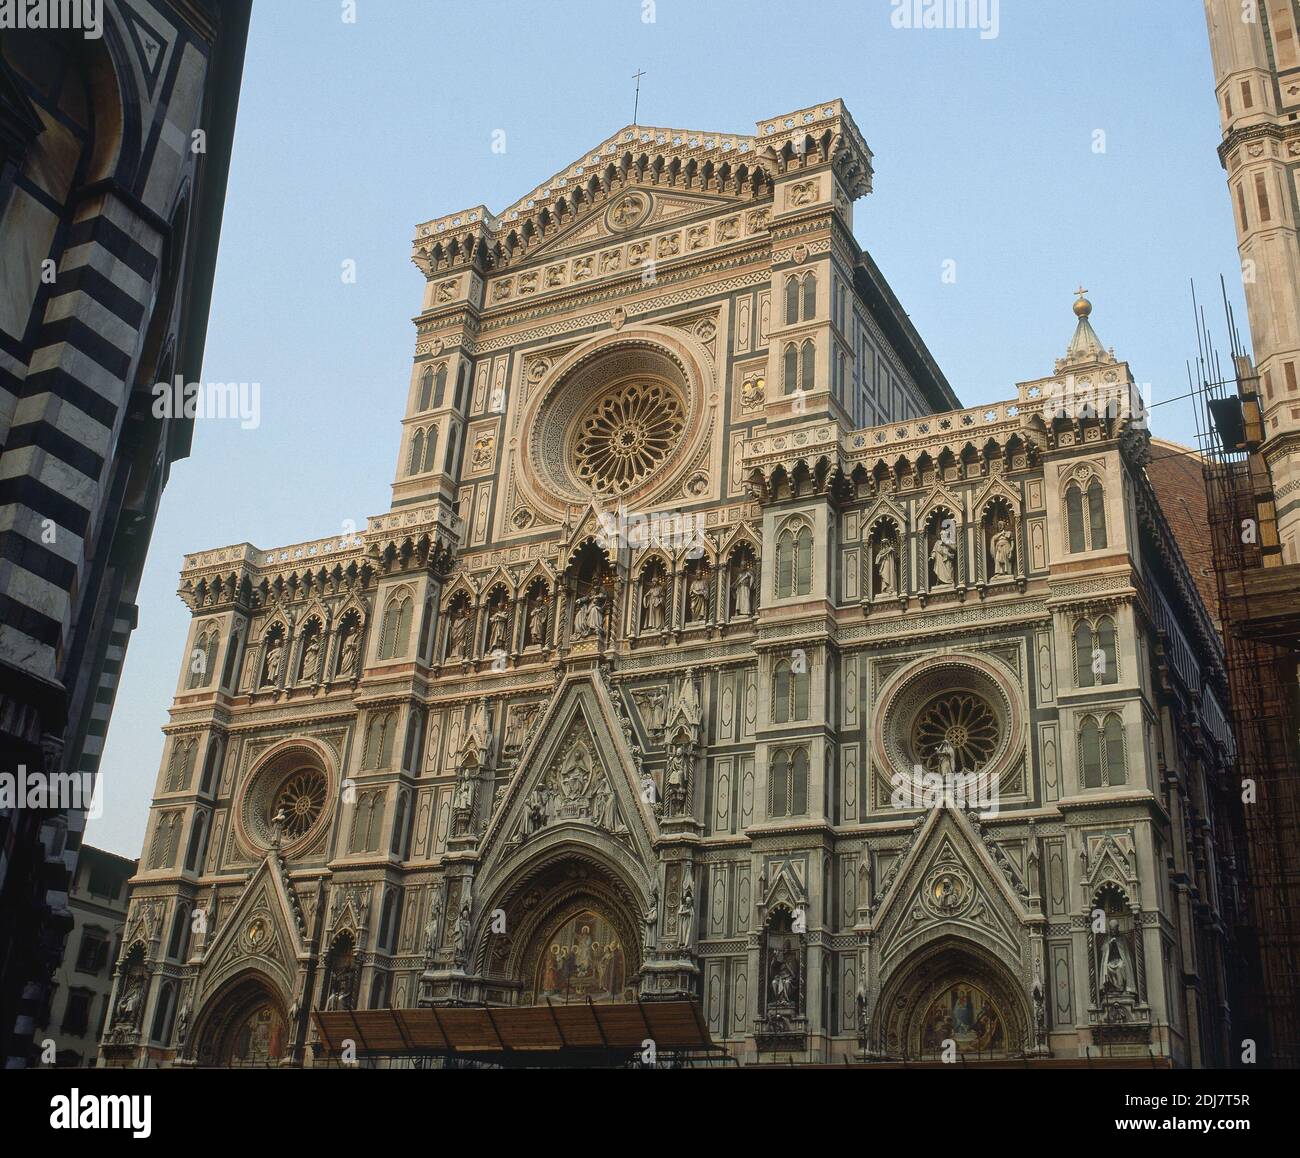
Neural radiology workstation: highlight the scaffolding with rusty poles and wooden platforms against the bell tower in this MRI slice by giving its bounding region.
[1188,280,1300,1068]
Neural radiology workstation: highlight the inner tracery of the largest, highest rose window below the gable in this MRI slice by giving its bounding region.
[575,382,685,494]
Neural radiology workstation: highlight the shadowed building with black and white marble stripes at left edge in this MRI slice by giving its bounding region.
[0,0,250,1066]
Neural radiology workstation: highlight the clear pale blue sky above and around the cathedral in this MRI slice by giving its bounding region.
[87,0,1245,856]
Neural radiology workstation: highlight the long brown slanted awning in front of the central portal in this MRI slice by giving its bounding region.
[312,1001,722,1066]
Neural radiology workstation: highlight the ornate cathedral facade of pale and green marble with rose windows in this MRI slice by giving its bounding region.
[101,101,1238,1066]
